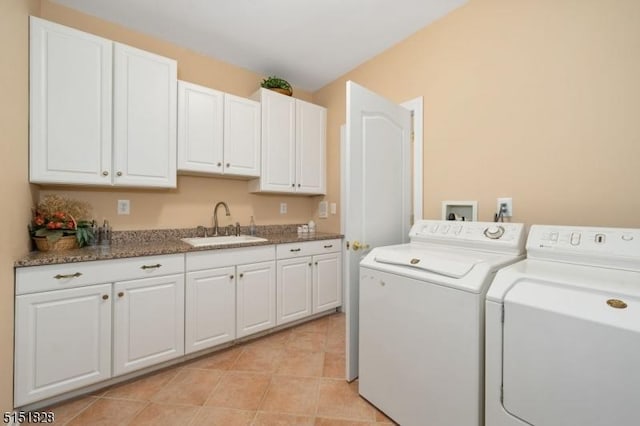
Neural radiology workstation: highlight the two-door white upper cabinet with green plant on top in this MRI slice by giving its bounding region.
[249,89,327,195]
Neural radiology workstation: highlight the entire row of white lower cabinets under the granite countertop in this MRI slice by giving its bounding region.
[14,239,342,407]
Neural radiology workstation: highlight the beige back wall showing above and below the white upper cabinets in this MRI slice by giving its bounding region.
[40,0,317,230]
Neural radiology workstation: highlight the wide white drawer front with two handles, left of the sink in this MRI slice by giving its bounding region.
[16,254,184,295]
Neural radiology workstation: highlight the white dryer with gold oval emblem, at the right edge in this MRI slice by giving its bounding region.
[485,225,640,426]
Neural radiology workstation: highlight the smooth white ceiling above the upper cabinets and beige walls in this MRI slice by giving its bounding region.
[52,0,467,91]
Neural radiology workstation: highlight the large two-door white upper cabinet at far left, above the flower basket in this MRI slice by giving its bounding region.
[29,17,177,188]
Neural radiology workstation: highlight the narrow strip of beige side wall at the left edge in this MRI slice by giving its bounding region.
[0,0,38,412]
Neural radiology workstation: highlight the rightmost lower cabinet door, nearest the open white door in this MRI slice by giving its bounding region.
[313,253,342,314]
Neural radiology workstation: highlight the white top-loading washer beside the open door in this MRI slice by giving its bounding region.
[359,220,525,426]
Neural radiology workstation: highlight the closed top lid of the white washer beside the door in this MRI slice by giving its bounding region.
[374,249,480,278]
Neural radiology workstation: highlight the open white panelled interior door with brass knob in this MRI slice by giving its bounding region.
[341,81,412,381]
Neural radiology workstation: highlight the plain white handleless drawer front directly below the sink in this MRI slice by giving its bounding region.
[186,245,276,272]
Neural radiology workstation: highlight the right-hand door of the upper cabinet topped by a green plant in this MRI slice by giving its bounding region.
[296,99,327,194]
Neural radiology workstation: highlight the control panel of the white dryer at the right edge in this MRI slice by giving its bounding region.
[527,225,640,270]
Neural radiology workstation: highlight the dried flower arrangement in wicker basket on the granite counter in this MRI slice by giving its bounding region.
[29,195,95,247]
